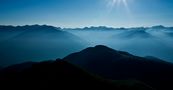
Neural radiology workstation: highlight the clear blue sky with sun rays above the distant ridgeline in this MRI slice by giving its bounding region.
[0,0,173,28]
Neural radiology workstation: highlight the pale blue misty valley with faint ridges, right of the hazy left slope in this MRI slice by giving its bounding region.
[68,27,173,62]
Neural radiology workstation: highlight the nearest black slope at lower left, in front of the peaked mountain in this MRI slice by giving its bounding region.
[0,60,153,90]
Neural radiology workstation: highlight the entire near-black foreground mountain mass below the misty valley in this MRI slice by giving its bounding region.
[0,45,173,90]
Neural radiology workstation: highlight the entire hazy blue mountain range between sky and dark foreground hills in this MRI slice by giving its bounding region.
[0,25,173,66]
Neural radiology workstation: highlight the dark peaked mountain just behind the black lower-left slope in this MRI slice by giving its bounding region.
[63,45,173,90]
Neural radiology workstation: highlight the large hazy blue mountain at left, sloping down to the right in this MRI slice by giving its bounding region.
[0,25,87,66]
